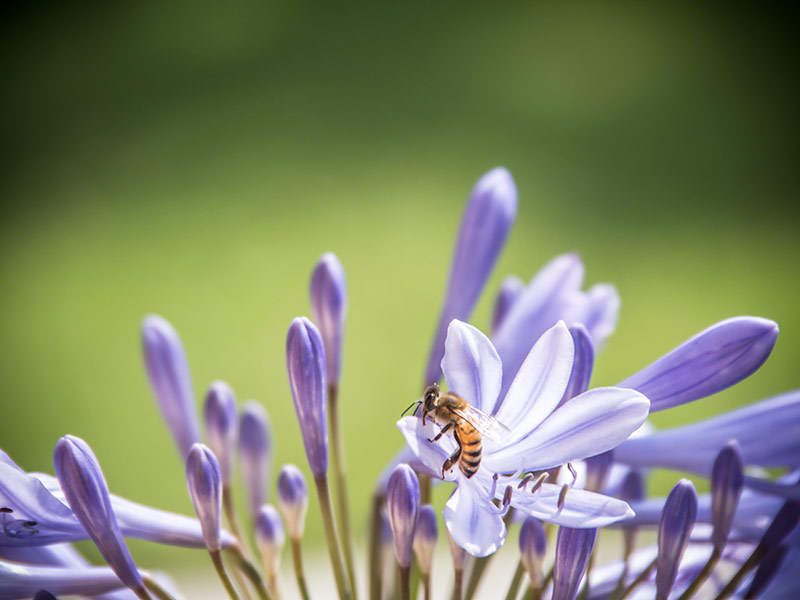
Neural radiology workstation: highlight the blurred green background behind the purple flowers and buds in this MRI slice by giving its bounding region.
[0,2,800,566]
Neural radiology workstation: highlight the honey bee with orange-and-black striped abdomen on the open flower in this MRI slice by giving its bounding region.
[406,383,509,479]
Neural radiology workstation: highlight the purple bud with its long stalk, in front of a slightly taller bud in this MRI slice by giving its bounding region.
[286,317,352,599]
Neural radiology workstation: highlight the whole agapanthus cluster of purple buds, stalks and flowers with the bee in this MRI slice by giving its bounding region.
[0,168,800,600]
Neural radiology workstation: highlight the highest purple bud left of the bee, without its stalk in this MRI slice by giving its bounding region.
[311,252,347,385]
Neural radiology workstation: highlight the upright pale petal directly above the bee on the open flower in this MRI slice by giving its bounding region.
[442,319,503,414]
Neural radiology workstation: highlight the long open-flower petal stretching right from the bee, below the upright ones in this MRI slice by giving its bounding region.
[483,388,650,473]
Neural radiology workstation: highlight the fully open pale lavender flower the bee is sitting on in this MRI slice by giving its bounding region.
[398,320,650,556]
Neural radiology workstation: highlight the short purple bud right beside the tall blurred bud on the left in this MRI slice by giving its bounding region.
[203,381,239,487]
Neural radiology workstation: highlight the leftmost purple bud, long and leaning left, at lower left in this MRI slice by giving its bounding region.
[53,435,144,593]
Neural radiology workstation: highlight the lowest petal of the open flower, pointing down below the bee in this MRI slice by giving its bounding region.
[444,479,506,556]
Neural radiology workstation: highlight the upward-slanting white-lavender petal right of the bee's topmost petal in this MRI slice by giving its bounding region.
[494,322,575,448]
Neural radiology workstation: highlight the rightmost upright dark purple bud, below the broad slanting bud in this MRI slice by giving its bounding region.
[711,442,744,551]
